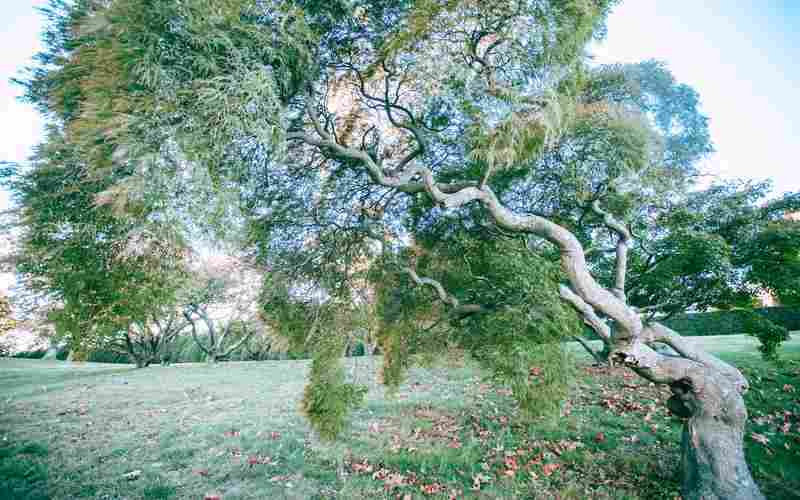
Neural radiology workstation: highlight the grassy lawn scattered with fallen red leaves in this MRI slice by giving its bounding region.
[0,335,800,500]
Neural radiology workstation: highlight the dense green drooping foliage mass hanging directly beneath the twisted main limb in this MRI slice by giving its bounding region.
[373,231,582,416]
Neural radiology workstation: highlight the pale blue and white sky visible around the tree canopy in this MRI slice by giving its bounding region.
[0,0,800,213]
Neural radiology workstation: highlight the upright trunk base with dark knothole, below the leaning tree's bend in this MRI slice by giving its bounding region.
[669,368,764,500]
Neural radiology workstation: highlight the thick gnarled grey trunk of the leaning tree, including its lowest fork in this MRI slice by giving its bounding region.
[612,324,764,500]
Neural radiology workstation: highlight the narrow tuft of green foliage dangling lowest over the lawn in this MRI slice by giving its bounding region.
[301,334,367,440]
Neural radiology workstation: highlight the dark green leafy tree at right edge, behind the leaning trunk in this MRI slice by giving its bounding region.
[612,181,800,358]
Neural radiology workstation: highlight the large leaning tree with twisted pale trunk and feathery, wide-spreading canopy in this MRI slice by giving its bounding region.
[14,0,776,499]
